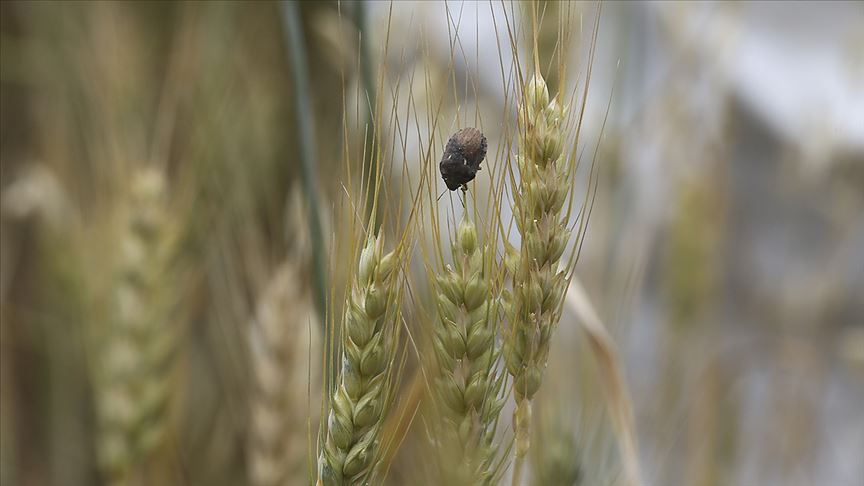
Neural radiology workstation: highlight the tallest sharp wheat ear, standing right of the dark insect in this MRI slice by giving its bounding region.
[503,74,570,484]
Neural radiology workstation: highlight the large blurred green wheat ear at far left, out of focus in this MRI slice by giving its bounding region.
[94,169,177,484]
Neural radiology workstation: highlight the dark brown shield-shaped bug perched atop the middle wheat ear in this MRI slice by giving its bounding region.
[438,127,486,192]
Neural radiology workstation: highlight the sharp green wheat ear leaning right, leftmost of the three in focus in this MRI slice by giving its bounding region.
[318,237,399,486]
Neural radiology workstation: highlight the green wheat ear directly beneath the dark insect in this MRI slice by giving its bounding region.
[433,218,504,484]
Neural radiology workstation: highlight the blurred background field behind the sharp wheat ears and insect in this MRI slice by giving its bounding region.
[0,1,864,486]
